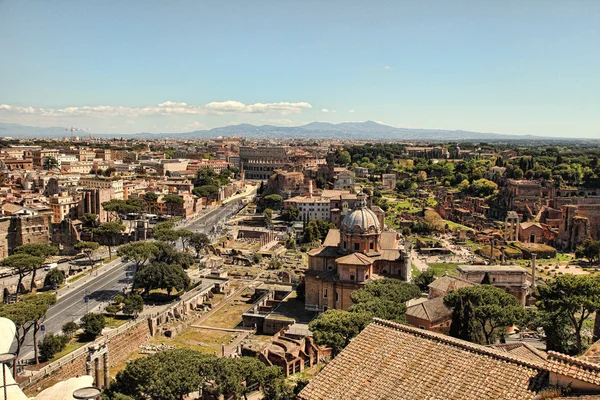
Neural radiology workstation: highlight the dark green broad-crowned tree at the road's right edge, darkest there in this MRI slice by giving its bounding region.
[135,262,190,296]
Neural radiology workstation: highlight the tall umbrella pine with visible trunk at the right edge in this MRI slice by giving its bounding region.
[536,274,600,354]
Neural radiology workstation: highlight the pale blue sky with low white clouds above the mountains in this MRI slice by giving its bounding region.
[0,0,600,138]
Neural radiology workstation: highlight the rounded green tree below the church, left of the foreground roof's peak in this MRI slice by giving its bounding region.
[308,310,371,355]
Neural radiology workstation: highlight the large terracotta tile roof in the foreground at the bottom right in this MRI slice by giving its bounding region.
[298,319,548,400]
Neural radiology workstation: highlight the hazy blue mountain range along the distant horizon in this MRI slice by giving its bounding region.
[0,121,592,142]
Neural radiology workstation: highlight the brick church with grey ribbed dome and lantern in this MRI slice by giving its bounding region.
[305,198,411,311]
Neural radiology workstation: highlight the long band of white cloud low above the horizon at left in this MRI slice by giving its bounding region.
[0,101,312,117]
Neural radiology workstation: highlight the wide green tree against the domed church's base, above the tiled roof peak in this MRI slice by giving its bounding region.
[349,278,421,323]
